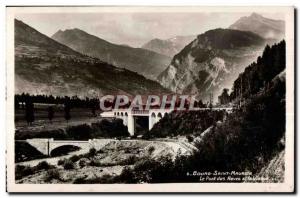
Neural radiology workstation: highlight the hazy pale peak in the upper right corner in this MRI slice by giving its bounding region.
[229,13,285,40]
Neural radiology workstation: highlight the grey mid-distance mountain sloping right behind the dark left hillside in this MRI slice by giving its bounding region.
[52,28,171,79]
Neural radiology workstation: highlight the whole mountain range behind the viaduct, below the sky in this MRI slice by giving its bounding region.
[15,13,285,100]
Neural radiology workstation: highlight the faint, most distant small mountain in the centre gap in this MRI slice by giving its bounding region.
[142,35,196,57]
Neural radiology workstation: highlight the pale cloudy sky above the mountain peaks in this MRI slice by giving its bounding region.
[16,13,283,47]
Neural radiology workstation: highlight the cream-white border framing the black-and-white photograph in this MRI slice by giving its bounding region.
[6,6,294,192]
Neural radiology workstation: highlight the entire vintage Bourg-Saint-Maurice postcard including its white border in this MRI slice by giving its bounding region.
[6,6,295,193]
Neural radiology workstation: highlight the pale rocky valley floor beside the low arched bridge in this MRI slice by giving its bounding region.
[16,139,194,183]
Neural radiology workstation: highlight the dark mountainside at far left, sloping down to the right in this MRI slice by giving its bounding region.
[15,20,167,96]
